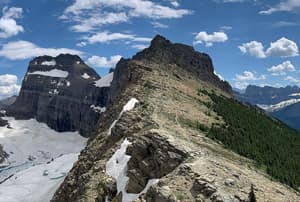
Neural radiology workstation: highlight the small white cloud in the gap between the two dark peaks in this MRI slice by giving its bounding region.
[87,55,122,68]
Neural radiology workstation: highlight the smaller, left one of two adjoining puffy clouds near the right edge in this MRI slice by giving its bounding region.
[239,41,266,58]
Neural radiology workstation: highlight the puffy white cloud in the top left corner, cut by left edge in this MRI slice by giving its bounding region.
[0,7,24,38]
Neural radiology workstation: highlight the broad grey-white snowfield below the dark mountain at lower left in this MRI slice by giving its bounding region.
[0,117,87,202]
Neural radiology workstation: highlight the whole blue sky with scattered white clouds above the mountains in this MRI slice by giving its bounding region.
[0,0,300,98]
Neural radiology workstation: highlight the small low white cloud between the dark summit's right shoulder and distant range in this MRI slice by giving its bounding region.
[233,71,266,89]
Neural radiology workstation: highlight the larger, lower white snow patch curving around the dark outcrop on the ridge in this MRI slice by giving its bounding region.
[106,139,159,202]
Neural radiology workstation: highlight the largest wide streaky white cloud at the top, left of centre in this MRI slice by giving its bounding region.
[60,0,192,32]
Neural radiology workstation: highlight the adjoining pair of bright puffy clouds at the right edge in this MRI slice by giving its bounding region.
[238,37,298,58]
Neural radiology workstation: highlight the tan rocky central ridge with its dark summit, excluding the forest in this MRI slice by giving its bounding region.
[52,36,300,202]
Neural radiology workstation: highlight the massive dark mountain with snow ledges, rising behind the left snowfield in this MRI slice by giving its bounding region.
[7,54,109,136]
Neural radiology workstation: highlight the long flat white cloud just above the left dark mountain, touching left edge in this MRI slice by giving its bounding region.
[0,41,82,60]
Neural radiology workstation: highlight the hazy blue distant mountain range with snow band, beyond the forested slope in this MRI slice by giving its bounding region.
[234,85,300,131]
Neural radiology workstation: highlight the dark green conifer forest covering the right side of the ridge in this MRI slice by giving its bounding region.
[199,91,300,189]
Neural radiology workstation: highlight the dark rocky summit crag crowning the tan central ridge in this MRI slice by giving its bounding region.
[133,35,232,94]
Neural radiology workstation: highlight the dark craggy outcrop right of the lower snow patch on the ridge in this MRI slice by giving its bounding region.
[127,134,188,193]
